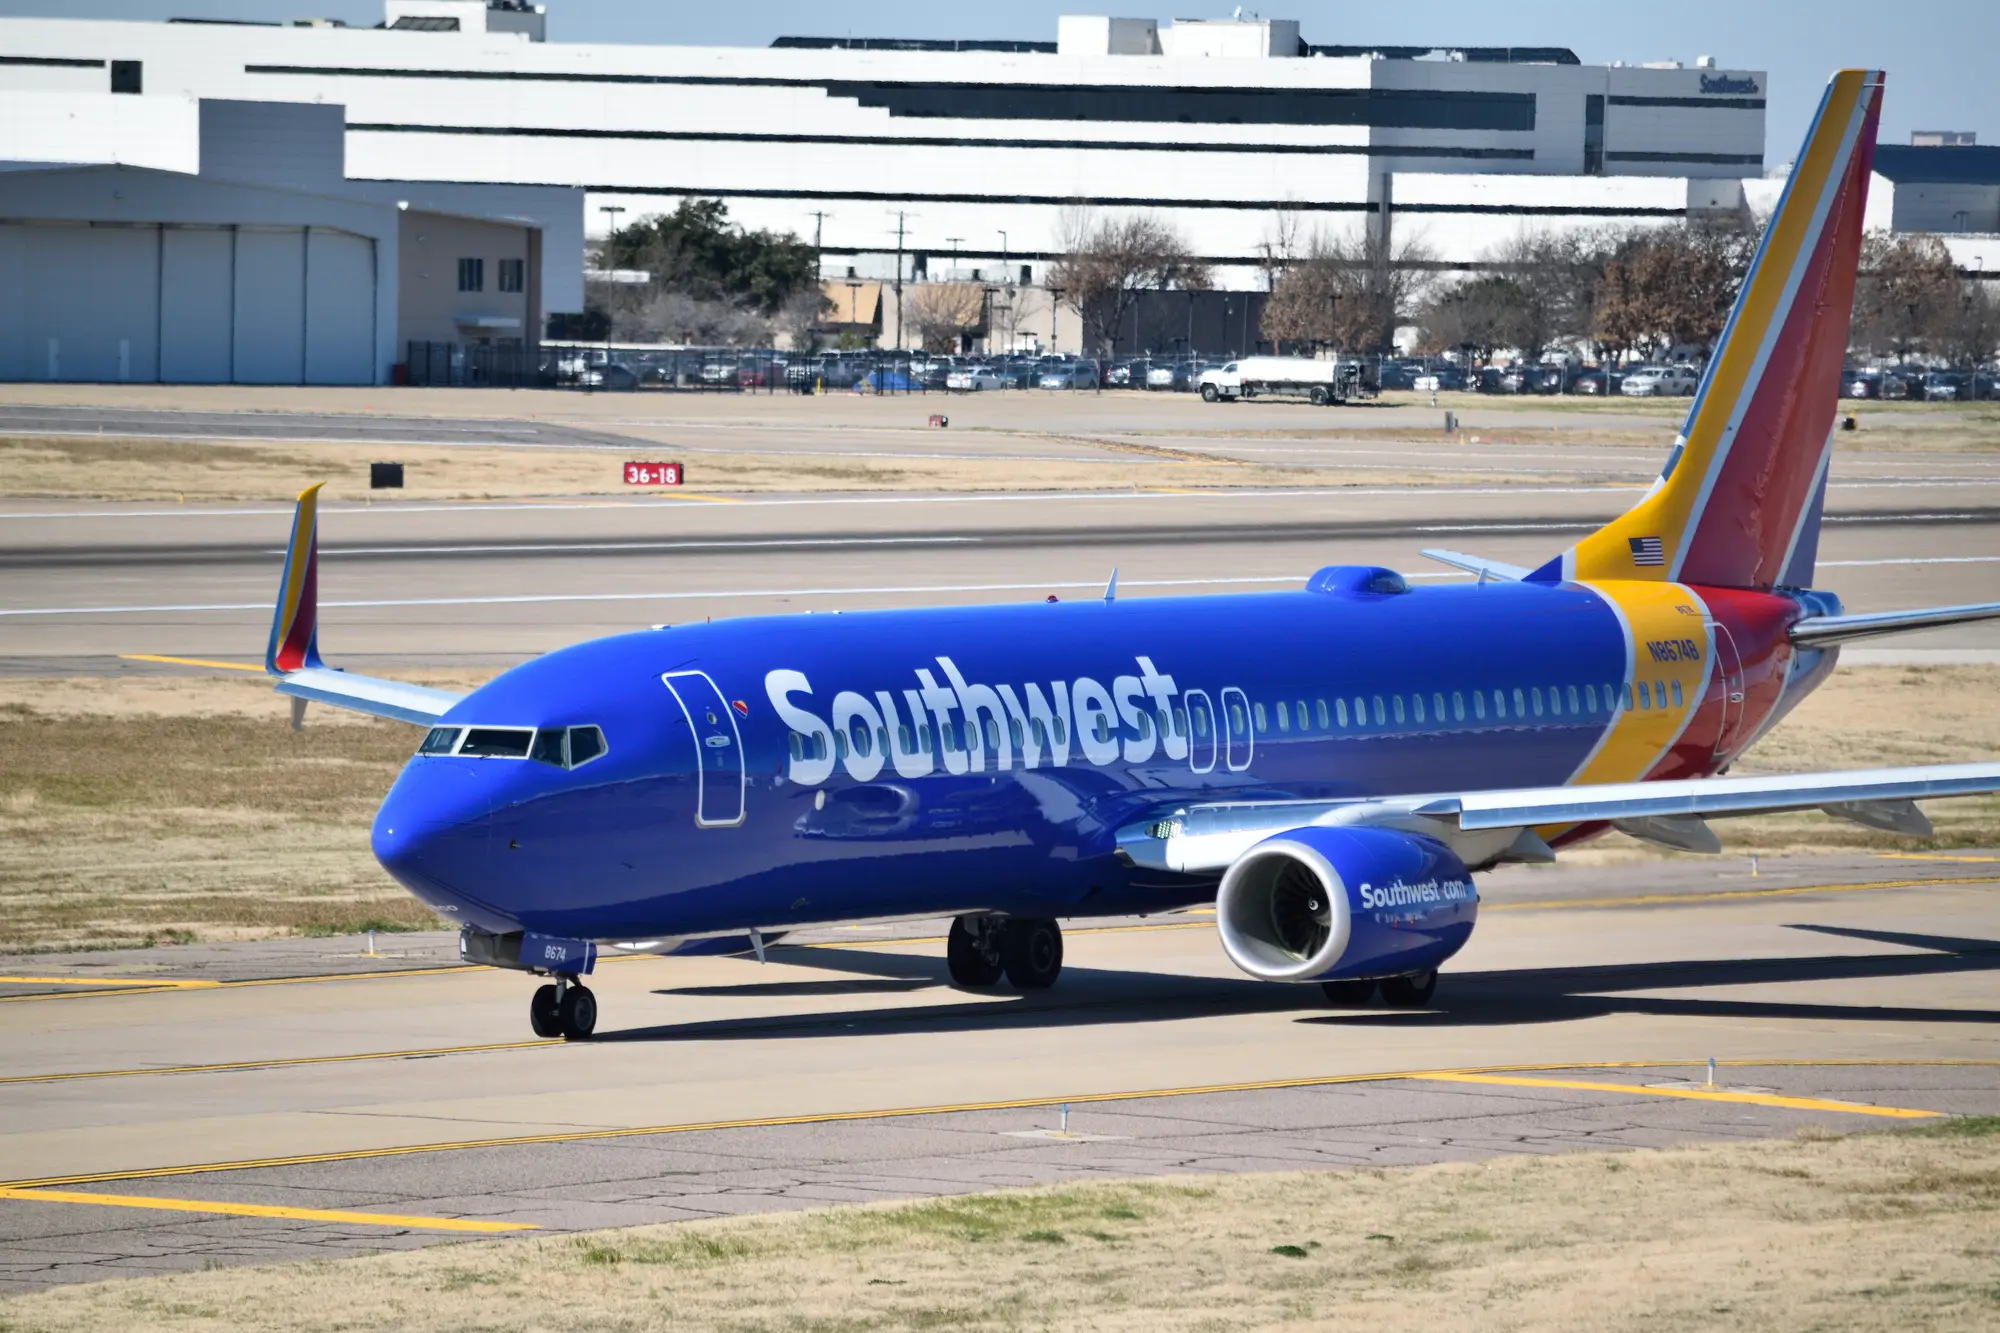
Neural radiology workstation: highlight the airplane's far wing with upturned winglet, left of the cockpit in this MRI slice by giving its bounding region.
[264,482,464,727]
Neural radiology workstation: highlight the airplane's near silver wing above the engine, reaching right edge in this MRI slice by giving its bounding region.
[1118,763,2000,875]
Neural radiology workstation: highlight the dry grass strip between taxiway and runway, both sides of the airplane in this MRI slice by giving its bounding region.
[0,667,2000,951]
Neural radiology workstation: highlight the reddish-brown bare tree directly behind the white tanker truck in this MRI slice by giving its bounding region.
[1260,228,1430,350]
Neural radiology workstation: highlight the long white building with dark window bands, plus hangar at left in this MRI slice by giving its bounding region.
[0,0,1766,368]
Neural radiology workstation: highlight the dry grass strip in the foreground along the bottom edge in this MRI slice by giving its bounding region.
[0,1119,2000,1333]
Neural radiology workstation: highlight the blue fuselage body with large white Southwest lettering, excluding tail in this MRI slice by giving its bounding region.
[374,570,1808,941]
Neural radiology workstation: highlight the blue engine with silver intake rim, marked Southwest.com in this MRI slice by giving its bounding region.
[1216,827,1480,981]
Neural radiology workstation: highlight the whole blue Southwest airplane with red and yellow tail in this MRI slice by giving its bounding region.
[266,70,2000,1039]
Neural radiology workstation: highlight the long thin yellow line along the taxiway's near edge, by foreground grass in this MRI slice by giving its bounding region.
[0,1059,1968,1195]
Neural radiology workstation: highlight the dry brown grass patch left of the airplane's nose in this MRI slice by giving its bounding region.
[0,677,486,951]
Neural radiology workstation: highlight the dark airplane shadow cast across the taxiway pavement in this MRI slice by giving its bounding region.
[598,925,2000,1041]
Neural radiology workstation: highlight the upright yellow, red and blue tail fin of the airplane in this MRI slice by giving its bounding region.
[1530,70,1882,588]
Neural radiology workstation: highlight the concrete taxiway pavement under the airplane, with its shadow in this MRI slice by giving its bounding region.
[0,853,2000,1287]
